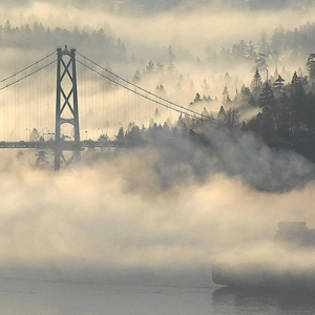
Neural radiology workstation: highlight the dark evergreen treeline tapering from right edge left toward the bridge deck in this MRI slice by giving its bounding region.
[111,54,315,161]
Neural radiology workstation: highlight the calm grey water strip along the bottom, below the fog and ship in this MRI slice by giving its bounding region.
[0,279,315,315]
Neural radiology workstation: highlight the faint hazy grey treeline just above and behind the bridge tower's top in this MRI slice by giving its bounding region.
[0,20,127,61]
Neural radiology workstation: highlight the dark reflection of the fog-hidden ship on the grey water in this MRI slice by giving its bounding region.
[213,288,315,315]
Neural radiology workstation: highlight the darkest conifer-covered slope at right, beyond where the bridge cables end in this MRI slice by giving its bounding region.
[205,54,315,160]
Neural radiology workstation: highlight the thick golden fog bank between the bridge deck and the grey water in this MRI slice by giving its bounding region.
[0,129,314,269]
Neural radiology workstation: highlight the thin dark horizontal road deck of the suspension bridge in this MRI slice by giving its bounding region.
[0,140,126,151]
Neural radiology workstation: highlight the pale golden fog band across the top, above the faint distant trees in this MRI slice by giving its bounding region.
[0,0,314,54]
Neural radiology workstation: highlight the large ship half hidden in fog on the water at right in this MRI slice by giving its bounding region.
[212,222,315,289]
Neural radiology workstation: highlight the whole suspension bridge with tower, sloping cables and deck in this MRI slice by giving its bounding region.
[0,46,208,170]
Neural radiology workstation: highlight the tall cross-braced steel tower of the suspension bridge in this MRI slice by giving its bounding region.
[55,46,81,170]
